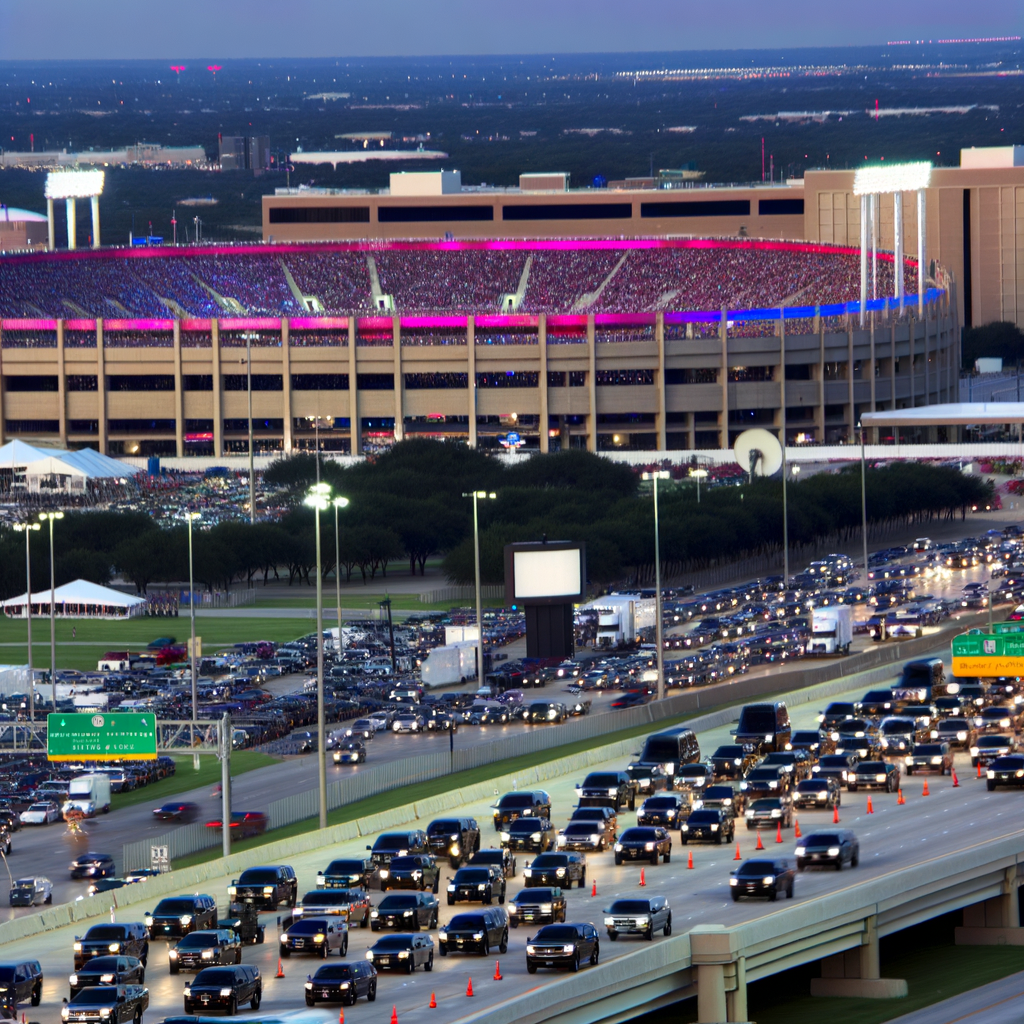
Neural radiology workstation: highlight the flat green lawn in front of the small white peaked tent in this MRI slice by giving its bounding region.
[0,615,310,672]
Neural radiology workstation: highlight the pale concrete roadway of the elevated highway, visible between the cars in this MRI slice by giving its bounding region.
[9,671,1024,1024]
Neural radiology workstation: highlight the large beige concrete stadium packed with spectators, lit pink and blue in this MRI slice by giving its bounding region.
[0,237,958,457]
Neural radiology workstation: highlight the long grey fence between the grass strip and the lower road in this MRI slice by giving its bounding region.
[121,613,985,871]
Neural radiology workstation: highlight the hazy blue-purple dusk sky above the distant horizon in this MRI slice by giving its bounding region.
[0,0,1024,59]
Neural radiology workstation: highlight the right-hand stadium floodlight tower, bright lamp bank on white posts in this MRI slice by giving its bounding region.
[853,162,932,327]
